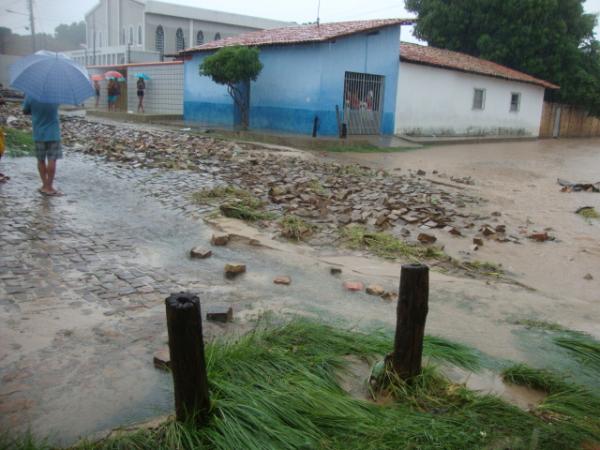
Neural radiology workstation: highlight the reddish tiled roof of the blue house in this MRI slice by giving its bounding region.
[181,19,414,53]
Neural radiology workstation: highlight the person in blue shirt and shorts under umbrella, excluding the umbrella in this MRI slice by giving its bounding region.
[23,97,62,196]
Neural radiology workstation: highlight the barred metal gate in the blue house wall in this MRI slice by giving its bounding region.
[344,72,384,134]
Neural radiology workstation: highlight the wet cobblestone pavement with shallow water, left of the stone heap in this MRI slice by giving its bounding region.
[0,152,408,443]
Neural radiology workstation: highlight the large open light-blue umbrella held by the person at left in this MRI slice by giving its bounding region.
[10,50,95,105]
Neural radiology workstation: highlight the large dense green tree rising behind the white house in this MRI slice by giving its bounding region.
[405,0,600,115]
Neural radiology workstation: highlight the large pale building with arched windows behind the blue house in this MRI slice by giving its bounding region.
[67,0,289,65]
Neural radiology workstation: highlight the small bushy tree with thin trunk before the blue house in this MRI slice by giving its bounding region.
[200,46,263,129]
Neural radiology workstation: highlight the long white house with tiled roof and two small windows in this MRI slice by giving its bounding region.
[395,44,556,137]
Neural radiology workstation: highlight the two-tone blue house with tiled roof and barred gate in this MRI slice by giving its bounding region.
[180,19,412,136]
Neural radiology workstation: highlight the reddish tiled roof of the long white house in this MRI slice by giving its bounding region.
[400,42,559,89]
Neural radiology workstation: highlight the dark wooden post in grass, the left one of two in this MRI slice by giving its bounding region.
[165,292,210,426]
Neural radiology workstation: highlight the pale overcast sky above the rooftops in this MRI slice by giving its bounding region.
[0,0,600,40]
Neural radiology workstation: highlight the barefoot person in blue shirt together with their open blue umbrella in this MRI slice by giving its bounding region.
[10,50,94,196]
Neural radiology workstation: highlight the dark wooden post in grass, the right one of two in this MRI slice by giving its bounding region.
[391,264,429,380]
